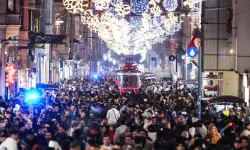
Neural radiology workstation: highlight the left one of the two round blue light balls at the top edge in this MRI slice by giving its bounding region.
[131,0,149,15]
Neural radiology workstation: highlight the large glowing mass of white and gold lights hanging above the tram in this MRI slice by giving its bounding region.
[63,0,180,62]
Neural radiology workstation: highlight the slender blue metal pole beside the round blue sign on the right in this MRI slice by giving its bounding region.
[197,47,202,119]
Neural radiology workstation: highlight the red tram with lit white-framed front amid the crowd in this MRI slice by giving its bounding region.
[116,64,142,93]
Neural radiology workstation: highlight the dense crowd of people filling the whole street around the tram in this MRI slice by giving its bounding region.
[0,79,250,150]
